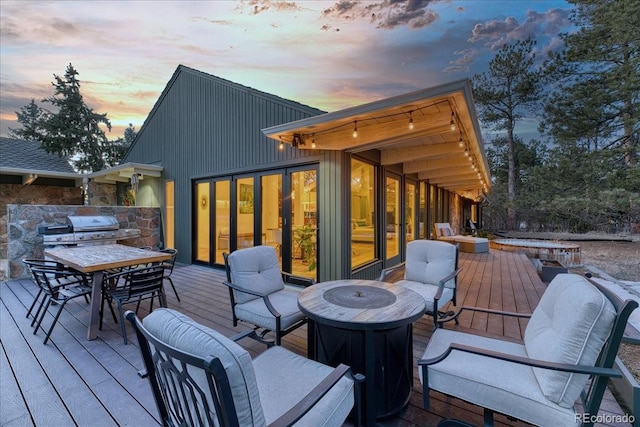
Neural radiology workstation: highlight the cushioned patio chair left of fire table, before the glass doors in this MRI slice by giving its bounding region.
[223,246,313,346]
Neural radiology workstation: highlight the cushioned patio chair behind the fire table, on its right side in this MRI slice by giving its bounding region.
[379,240,461,328]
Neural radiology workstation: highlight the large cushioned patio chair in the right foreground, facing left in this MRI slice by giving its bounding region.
[418,274,638,426]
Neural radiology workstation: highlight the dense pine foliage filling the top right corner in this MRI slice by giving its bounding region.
[541,0,640,168]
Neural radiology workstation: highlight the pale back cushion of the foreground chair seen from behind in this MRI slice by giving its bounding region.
[142,308,266,426]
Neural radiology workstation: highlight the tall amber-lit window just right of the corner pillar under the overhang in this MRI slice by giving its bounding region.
[351,159,376,268]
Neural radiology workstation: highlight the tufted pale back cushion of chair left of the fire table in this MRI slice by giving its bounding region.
[228,246,284,303]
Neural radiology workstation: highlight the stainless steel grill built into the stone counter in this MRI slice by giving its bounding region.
[38,215,140,247]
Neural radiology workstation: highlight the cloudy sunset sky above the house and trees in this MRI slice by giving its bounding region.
[0,0,572,140]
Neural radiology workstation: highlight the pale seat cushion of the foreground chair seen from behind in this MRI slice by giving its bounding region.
[254,346,354,427]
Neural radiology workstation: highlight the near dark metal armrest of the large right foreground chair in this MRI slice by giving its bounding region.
[418,343,622,378]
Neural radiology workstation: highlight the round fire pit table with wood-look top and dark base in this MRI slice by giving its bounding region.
[298,280,426,426]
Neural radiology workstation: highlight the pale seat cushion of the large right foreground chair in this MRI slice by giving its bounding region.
[419,328,576,426]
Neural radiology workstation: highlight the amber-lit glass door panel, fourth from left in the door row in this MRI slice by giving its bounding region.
[260,173,282,268]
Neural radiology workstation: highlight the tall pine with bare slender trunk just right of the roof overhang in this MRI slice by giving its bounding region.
[473,39,543,230]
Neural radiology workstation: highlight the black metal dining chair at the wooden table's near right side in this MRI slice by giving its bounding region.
[100,265,167,344]
